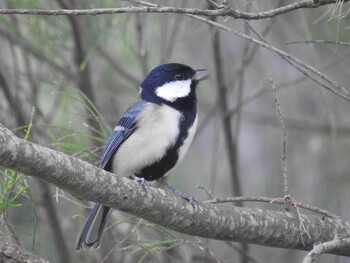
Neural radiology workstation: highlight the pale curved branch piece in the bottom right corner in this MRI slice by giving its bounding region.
[303,235,350,263]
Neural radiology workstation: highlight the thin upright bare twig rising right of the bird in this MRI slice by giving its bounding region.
[269,75,289,196]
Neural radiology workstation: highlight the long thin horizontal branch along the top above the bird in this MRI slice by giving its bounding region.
[0,0,349,20]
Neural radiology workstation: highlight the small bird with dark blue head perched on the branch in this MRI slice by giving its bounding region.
[75,63,207,251]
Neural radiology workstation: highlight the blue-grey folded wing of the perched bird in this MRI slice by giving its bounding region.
[100,101,146,171]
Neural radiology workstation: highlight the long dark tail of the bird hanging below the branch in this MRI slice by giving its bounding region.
[75,204,111,250]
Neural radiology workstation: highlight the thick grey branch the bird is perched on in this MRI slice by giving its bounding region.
[0,124,350,256]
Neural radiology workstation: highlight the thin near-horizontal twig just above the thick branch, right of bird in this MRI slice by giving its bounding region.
[203,197,339,218]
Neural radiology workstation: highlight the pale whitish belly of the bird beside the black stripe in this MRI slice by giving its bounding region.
[112,103,182,176]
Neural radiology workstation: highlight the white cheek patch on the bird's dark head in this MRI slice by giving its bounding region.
[156,79,191,102]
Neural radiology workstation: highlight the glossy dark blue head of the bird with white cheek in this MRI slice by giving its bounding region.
[141,63,206,107]
